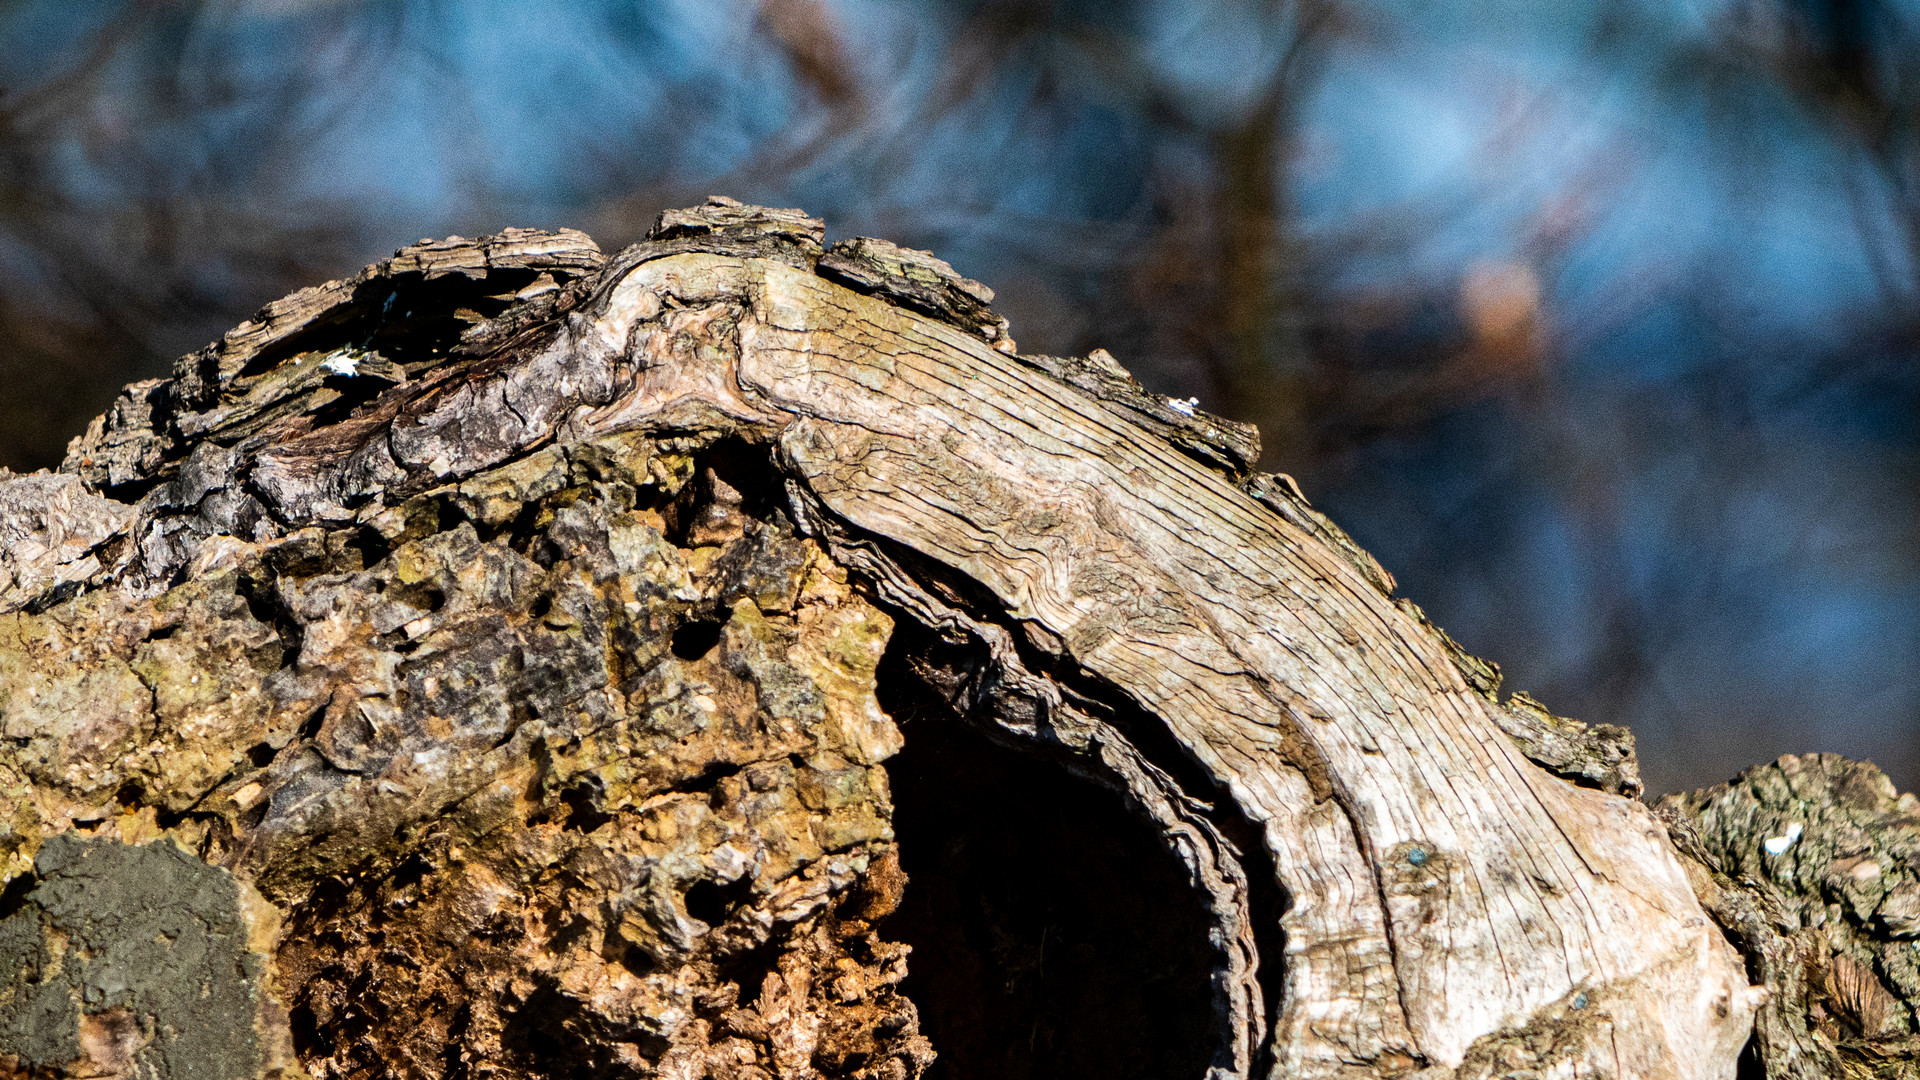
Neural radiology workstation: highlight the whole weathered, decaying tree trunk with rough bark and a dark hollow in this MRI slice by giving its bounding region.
[0,198,1920,1080]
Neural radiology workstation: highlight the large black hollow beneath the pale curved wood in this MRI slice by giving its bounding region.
[883,715,1217,1080]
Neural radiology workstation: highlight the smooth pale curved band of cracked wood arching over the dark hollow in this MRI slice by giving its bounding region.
[576,208,1757,1076]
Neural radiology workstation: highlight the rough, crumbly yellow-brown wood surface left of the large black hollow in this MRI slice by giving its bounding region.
[0,426,931,1076]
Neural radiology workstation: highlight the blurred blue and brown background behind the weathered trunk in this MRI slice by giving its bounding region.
[0,0,1920,792]
